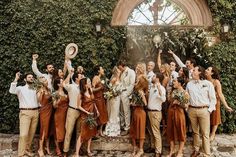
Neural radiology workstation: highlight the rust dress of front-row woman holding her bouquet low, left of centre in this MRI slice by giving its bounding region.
[80,96,97,142]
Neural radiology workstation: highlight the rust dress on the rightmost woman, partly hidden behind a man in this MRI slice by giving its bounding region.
[211,81,221,125]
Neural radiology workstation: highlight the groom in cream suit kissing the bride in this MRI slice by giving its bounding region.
[118,61,135,136]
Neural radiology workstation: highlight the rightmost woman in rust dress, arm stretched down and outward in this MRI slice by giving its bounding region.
[205,67,233,141]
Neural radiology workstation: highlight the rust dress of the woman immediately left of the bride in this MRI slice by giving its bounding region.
[93,82,108,125]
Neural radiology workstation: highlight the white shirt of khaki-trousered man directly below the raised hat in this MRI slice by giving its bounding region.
[64,83,80,108]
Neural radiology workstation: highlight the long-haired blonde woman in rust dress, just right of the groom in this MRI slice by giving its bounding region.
[130,75,148,157]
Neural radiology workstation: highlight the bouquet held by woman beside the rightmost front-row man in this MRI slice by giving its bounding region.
[172,90,189,108]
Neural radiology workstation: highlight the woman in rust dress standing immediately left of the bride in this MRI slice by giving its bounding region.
[92,66,108,136]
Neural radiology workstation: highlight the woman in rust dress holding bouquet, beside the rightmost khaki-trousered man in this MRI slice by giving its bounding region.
[167,77,189,157]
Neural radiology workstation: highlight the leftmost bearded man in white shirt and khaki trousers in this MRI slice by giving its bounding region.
[9,72,39,157]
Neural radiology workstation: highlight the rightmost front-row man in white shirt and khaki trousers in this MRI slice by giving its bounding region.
[186,66,216,157]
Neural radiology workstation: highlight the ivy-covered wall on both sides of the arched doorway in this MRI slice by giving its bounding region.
[0,0,236,133]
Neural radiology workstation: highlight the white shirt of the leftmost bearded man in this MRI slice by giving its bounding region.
[9,82,39,108]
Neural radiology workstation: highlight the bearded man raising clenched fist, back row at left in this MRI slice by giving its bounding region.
[32,54,54,90]
